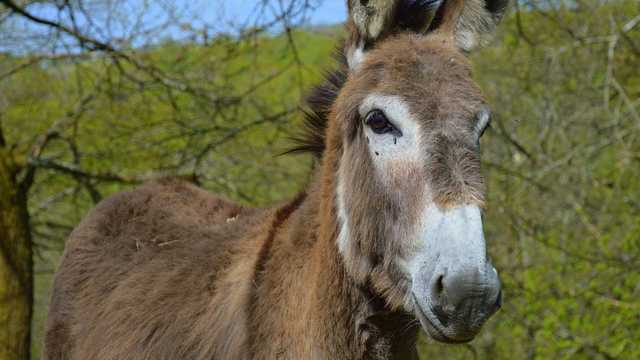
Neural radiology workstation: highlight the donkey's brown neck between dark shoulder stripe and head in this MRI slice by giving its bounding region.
[249,155,418,359]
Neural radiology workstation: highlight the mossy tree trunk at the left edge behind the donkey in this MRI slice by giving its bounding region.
[0,148,33,360]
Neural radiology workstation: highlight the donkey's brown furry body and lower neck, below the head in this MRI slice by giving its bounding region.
[45,176,417,360]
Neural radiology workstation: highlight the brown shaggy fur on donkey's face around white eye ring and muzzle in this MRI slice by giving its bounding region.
[326,35,485,307]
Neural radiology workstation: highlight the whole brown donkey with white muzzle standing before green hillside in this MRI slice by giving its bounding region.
[44,0,508,360]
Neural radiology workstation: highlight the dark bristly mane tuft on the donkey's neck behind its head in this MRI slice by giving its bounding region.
[285,50,348,158]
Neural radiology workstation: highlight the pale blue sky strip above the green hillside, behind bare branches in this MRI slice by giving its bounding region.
[0,0,347,53]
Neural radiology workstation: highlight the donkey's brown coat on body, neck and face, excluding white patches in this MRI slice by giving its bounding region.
[44,2,498,360]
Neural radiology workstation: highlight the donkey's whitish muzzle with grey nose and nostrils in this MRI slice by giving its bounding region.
[411,206,502,343]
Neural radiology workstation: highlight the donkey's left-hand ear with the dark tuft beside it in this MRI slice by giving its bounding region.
[345,0,443,70]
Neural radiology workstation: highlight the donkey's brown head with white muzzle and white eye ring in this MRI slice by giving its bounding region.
[327,0,508,342]
